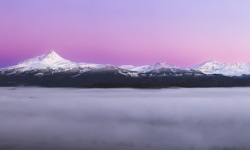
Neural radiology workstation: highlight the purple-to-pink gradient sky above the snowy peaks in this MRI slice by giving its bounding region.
[0,0,250,67]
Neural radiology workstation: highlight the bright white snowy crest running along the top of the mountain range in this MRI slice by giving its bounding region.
[0,50,250,76]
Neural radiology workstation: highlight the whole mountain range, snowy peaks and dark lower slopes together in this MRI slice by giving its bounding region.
[0,51,250,87]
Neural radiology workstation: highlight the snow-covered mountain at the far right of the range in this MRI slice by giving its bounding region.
[192,61,250,76]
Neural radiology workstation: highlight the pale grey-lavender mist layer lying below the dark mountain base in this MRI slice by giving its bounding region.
[0,87,250,150]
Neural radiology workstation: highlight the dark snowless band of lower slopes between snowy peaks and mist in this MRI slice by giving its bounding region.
[0,71,250,88]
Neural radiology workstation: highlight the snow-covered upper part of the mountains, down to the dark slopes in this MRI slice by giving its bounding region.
[0,51,250,76]
